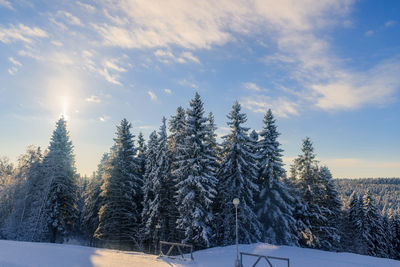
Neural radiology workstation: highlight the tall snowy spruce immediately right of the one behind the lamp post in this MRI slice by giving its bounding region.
[256,110,298,245]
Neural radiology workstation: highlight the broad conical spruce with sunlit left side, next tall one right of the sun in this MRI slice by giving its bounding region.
[94,119,143,249]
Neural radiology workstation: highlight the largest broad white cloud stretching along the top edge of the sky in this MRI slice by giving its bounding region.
[93,0,354,49]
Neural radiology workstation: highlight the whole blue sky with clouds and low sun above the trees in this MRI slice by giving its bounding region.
[0,0,400,177]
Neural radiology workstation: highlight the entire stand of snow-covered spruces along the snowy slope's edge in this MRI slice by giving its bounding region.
[0,93,400,259]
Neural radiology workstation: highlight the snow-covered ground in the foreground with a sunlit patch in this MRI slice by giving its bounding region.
[0,240,400,267]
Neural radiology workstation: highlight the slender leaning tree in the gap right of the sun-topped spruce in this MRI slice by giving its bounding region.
[81,153,108,245]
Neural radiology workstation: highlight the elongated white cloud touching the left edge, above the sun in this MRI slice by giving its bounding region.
[0,24,48,43]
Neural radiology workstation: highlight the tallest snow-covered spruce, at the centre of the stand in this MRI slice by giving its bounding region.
[174,93,217,248]
